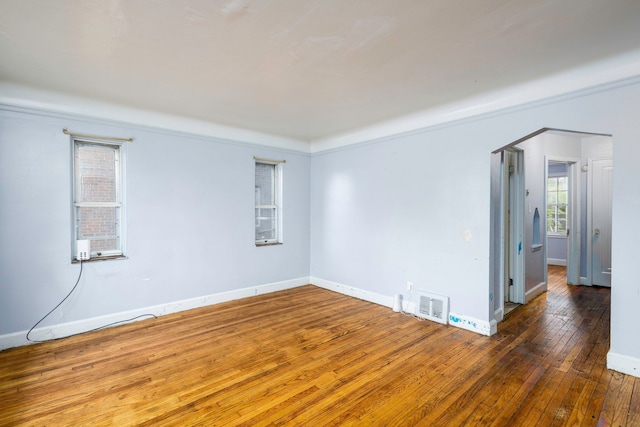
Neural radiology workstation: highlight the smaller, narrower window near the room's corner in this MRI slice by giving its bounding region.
[255,161,282,245]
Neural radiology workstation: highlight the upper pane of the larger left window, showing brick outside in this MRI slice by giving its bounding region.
[75,144,117,202]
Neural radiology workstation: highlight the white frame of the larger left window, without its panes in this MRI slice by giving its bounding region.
[71,137,126,260]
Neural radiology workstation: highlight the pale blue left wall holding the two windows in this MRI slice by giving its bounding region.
[0,106,310,334]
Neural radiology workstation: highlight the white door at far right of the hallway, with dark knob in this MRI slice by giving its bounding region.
[589,159,613,286]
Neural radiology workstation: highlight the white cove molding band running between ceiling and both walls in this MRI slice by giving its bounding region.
[0,49,640,154]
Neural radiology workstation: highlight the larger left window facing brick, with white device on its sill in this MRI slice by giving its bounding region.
[73,139,124,258]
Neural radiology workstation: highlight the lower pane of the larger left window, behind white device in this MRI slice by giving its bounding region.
[77,207,120,252]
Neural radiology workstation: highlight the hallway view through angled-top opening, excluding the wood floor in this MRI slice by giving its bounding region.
[490,128,613,322]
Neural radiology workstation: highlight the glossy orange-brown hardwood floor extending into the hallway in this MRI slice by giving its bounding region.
[0,267,640,426]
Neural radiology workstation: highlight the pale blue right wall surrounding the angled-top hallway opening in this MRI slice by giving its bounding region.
[311,77,640,358]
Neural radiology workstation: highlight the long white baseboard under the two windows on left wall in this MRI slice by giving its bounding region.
[0,277,310,350]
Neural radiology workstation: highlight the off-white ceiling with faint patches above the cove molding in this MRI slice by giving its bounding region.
[0,0,640,142]
